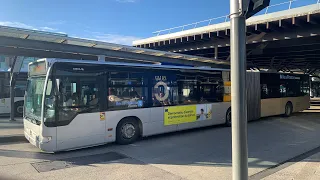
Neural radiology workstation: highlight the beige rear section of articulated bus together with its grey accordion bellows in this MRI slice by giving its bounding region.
[225,71,310,121]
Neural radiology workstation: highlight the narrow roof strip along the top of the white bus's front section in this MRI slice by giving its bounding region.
[34,58,230,71]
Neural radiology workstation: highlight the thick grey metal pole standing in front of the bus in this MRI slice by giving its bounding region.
[230,0,248,180]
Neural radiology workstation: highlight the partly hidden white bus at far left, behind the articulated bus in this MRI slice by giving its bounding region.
[0,71,28,117]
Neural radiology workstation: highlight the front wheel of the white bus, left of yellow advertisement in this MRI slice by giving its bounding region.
[116,117,140,145]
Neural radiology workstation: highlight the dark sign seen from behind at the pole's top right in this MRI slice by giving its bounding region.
[240,0,270,19]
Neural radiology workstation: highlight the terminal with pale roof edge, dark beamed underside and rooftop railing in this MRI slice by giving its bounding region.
[133,0,320,74]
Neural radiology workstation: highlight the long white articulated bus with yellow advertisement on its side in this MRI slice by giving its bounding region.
[24,59,309,152]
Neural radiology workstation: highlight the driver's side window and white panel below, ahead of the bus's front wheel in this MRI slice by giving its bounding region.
[57,76,106,150]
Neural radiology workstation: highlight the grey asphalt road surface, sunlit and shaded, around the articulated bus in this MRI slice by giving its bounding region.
[0,109,320,180]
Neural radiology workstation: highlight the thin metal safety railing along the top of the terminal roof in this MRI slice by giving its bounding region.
[153,0,320,36]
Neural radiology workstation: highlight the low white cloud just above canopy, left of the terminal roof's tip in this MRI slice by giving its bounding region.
[84,32,140,46]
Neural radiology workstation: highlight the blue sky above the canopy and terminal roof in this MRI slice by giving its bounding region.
[0,0,317,45]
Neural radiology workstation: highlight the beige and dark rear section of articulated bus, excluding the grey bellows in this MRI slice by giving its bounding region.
[260,73,310,117]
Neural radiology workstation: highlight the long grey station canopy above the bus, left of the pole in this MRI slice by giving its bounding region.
[0,26,229,68]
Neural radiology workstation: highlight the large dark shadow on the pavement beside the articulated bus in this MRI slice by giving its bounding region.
[0,112,320,177]
